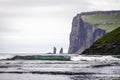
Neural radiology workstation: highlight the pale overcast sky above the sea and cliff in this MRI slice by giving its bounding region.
[0,0,120,54]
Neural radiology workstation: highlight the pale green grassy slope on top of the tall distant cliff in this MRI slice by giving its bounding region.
[82,14,120,32]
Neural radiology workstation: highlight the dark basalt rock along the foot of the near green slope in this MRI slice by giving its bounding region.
[82,42,120,55]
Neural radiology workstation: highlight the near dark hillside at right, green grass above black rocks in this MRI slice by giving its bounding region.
[82,27,120,55]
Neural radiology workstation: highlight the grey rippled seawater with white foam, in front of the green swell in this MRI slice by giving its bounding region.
[0,55,120,80]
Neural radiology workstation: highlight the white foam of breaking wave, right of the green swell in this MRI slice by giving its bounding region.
[71,55,120,61]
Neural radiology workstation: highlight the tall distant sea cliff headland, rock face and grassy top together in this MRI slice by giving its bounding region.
[68,11,120,54]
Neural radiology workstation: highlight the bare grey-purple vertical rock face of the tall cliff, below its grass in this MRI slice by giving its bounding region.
[68,14,106,54]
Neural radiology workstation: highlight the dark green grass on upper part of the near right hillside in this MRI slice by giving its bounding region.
[96,27,120,44]
